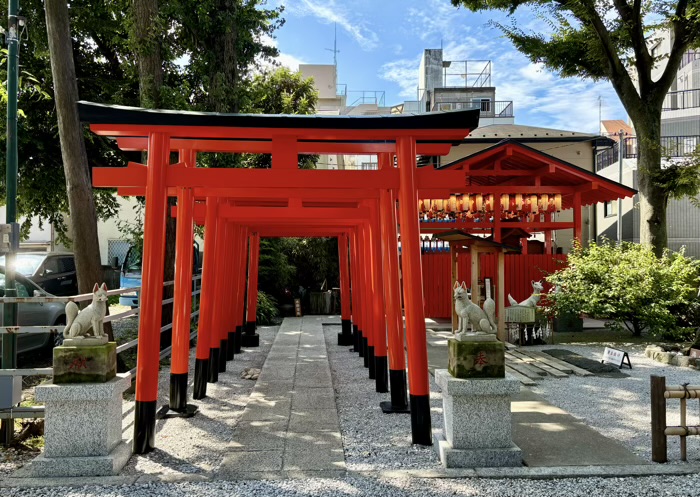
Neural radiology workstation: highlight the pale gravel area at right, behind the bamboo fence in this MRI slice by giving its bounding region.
[531,344,700,464]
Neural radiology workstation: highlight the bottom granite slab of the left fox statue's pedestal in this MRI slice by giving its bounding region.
[14,442,131,478]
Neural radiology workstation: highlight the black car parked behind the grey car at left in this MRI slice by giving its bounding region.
[0,252,78,297]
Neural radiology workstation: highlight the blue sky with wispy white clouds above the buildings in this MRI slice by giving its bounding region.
[269,0,626,132]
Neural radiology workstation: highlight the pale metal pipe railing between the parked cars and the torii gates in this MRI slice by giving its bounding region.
[0,275,202,419]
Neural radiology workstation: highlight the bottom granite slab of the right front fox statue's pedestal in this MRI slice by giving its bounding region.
[433,433,523,468]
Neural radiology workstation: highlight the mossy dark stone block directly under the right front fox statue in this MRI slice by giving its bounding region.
[447,338,506,379]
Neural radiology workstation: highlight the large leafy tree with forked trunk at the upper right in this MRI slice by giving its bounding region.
[452,0,700,255]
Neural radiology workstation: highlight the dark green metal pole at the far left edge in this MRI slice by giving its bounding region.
[0,0,24,446]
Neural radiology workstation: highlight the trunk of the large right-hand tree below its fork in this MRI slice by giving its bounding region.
[633,111,668,256]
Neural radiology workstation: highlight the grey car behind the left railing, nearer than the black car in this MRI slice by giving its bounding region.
[0,266,66,360]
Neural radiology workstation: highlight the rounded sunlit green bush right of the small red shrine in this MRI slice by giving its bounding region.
[547,241,700,336]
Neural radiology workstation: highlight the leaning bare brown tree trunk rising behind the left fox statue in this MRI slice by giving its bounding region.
[44,0,114,340]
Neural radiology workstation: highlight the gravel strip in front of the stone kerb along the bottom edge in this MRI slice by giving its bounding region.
[2,475,700,497]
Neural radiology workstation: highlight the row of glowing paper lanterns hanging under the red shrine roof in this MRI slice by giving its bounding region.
[418,193,562,214]
